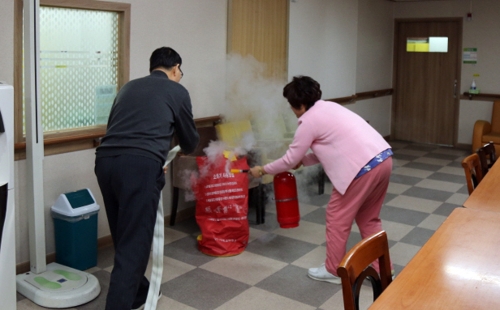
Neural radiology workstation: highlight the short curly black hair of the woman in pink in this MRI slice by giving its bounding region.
[283,76,321,111]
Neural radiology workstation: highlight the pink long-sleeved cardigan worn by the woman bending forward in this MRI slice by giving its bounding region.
[264,100,391,195]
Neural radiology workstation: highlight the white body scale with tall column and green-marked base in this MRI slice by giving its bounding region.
[16,0,101,308]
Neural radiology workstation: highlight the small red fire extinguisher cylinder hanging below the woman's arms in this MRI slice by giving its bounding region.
[273,172,300,228]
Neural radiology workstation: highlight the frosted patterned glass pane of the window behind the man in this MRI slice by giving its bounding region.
[35,7,119,132]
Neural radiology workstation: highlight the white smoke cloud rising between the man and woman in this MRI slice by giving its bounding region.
[182,54,326,200]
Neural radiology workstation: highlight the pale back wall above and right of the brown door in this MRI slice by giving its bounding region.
[395,0,500,144]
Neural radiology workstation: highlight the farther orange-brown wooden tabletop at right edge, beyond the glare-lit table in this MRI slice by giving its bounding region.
[464,160,500,212]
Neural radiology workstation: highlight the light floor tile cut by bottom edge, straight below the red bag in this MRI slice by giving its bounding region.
[216,283,316,310]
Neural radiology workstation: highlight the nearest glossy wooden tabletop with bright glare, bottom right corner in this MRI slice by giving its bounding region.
[370,208,500,310]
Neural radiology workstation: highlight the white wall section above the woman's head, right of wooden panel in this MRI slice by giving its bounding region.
[288,0,358,98]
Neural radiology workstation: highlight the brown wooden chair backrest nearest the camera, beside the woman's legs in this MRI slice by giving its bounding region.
[337,231,392,310]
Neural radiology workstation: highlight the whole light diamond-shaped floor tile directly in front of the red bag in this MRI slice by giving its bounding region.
[200,251,287,285]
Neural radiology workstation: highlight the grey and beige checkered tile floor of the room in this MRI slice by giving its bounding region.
[17,142,468,310]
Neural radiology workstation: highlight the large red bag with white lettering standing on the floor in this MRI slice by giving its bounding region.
[194,155,249,256]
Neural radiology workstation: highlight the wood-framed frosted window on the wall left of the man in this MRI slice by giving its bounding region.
[15,0,130,157]
